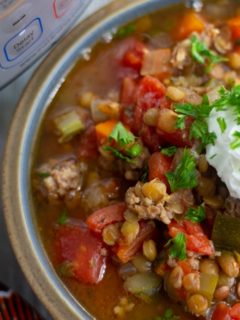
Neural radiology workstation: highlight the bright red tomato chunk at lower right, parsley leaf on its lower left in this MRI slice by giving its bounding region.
[168,220,214,256]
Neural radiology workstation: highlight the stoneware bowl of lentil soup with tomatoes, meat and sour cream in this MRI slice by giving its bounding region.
[3,0,240,320]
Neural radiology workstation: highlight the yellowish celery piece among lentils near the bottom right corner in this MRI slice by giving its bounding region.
[199,273,218,301]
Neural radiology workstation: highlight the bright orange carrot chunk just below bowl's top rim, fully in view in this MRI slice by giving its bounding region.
[173,11,205,40]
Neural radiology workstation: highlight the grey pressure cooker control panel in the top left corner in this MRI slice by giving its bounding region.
[0,0,91,89]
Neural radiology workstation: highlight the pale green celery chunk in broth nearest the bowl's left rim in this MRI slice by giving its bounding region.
[54,111,85,143]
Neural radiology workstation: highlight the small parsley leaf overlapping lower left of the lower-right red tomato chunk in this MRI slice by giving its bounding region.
[165,232,187,260]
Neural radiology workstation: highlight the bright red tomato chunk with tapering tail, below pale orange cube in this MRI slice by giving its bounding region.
[134,76,166,132]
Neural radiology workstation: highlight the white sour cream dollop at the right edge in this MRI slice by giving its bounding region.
[206,107,240,198]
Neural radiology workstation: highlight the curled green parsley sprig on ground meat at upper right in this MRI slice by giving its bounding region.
[191,36,227,71]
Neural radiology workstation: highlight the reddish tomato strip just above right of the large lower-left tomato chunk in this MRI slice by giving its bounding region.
[86,202,126,233]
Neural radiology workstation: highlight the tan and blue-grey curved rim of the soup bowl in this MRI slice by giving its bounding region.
[3,0,179,320]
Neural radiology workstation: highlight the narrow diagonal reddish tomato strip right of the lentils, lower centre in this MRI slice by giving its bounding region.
[116,222,155,263]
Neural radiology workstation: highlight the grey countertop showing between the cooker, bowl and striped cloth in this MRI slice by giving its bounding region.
[0,0,110,320]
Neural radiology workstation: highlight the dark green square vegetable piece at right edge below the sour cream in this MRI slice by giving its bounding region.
[212,214,240,251]
